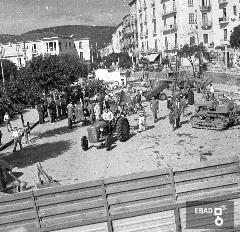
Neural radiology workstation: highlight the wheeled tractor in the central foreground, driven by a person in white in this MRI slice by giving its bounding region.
[81,115,130,151]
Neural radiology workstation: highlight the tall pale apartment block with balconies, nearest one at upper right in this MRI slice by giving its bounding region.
[137,0,240,65]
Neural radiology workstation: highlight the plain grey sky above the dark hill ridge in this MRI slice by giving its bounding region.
[0,0,130,35]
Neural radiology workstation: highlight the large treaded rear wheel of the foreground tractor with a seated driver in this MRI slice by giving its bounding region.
[116,117,130,142]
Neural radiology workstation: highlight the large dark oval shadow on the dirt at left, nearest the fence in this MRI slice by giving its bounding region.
[3,140,71,168]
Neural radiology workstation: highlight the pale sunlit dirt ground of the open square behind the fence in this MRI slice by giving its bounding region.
[2,83,240,189]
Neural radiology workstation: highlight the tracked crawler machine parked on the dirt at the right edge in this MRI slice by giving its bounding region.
[190,100,240,130]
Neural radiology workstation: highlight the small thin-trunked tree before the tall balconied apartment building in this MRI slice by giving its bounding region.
[177,43,206,75]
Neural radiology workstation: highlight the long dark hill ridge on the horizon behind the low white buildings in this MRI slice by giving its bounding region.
[0,25,116,49]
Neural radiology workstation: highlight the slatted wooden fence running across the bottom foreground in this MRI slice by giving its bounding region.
[0,158,240,232]
